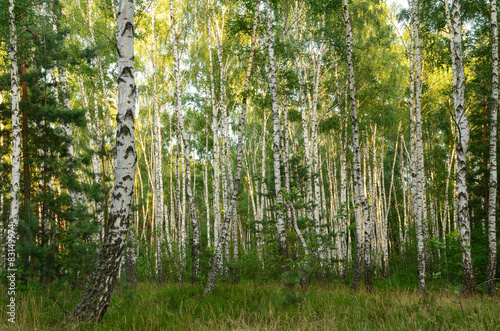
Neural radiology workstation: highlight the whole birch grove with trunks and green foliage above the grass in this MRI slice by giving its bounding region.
[0,0,499,327]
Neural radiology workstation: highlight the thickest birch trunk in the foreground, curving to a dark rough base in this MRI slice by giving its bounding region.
[68,0,137,324]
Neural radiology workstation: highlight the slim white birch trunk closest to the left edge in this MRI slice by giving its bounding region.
[5,0,21,288]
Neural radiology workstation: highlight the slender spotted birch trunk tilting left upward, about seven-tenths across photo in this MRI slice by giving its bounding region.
[342,0,371,290]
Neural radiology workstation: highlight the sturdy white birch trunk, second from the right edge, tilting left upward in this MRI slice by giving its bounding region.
[451,0,476,295]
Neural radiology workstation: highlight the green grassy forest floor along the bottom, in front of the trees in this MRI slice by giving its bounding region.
[0,282,500,331]
